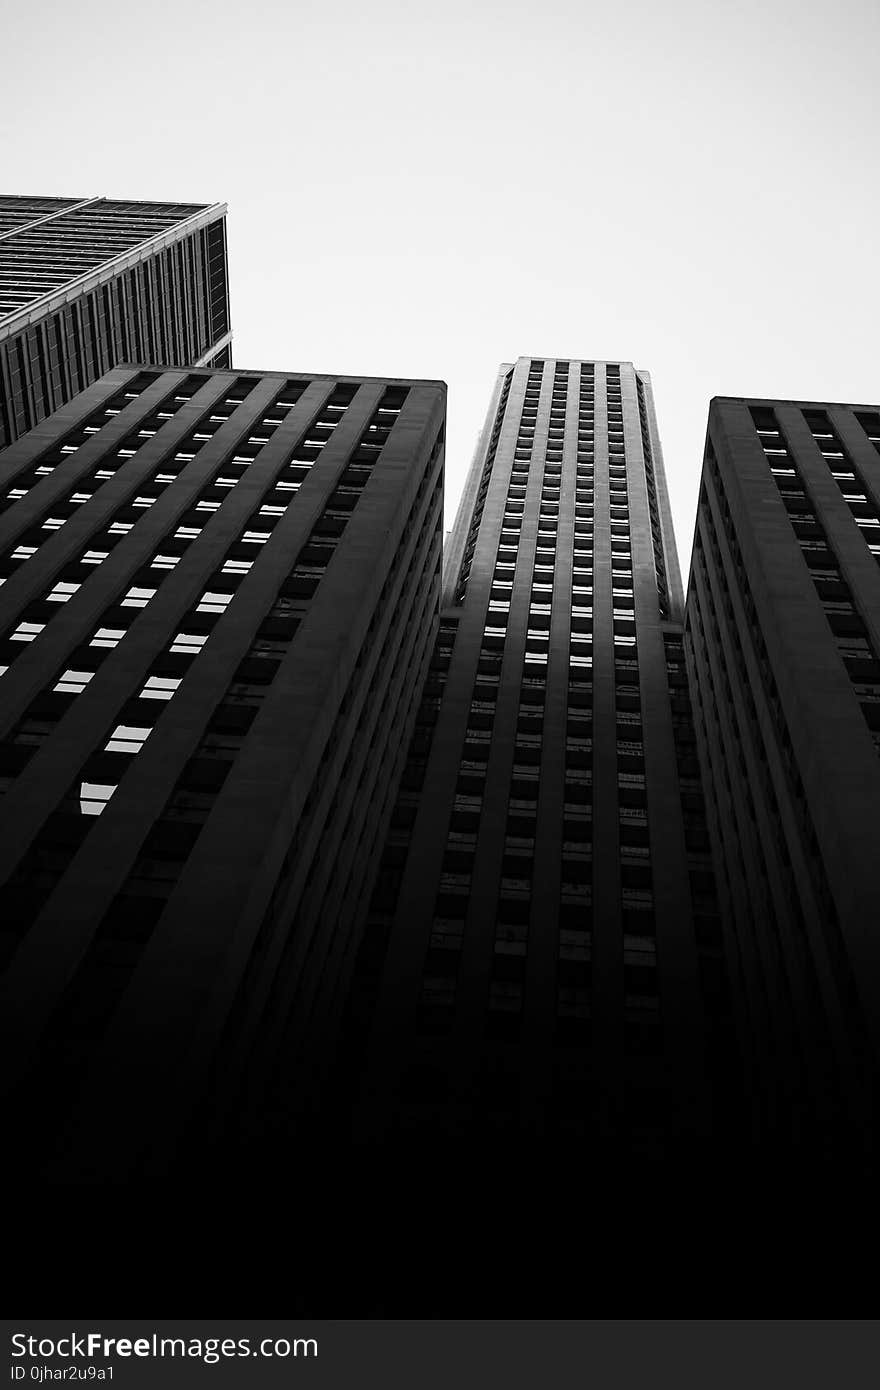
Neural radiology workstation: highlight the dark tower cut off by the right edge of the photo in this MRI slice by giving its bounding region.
[685,398,880,1180]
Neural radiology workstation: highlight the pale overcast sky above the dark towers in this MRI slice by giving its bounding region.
[0,0,880,581]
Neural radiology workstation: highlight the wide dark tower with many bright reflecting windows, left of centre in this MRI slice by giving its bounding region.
[0,368,445,1180]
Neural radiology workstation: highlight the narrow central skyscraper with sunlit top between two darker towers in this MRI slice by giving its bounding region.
[341,357,726,1161]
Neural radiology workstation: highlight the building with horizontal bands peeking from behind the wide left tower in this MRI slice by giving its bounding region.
[0,196,232,449]
